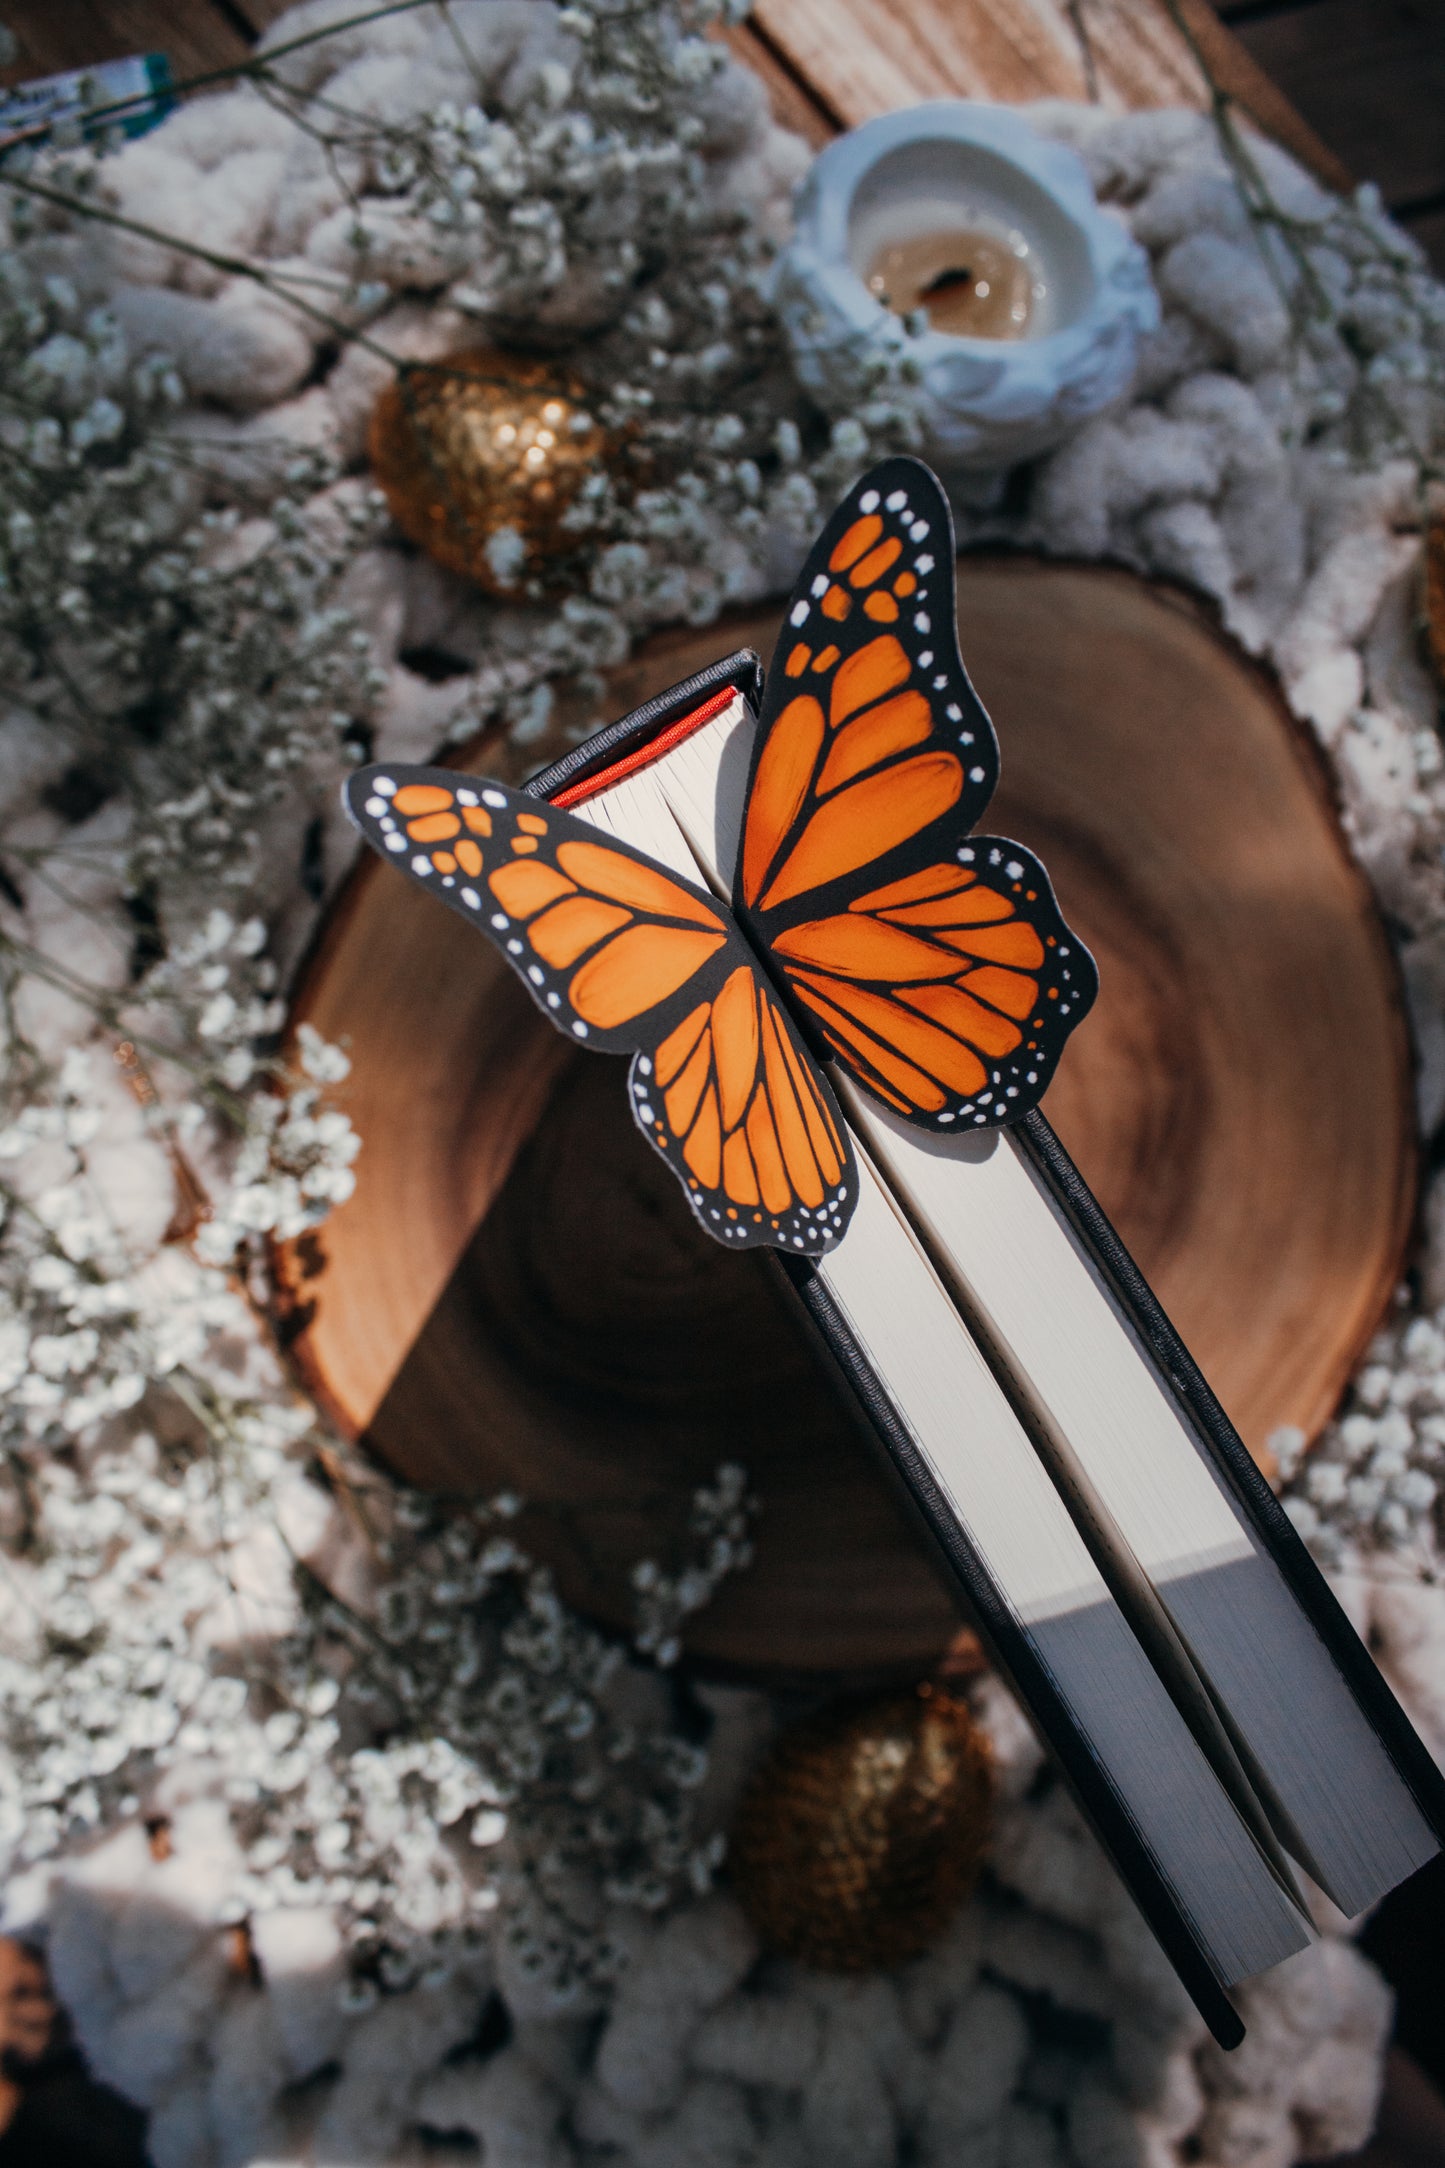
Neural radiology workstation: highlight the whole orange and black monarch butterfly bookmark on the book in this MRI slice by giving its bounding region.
[347,460,1098,1255]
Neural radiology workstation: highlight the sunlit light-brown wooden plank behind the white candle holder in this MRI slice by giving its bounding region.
[754,0,1345,186]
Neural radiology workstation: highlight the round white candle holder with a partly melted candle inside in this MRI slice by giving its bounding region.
[773,98,1159,470]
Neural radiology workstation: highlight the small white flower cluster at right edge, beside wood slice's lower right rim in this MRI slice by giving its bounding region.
[1272,1305,1445,1565]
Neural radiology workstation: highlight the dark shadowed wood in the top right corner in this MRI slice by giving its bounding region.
[1235,0,1445,204]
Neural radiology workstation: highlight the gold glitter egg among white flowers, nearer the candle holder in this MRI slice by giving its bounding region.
[368,347,615,596]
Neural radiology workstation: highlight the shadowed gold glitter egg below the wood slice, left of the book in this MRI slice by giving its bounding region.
[728,1685,992,1973]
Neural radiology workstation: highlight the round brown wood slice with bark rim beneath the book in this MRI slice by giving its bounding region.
[279,557,1415,1672]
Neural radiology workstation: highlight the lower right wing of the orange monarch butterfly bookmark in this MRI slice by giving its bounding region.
[773,837,1098,1134]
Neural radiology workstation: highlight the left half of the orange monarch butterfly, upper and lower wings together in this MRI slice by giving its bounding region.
[344,763,858,1255]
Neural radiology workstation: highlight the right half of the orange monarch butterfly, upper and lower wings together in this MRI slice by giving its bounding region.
[734,460,1098,1132]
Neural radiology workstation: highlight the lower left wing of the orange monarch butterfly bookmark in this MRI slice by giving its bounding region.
[628,960,858,1255]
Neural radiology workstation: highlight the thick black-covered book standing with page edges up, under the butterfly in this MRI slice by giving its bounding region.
[529,653,1445,2044]
